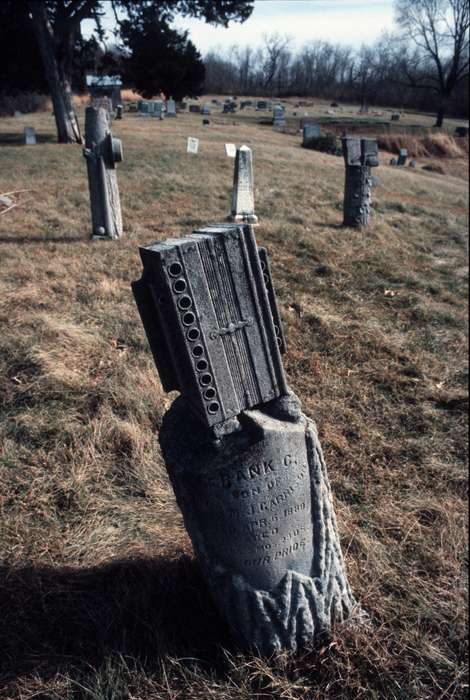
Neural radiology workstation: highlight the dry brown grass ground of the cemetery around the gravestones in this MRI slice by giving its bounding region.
[0,105,468,700]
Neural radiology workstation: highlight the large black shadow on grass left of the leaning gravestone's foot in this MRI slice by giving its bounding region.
[0,556,231,683]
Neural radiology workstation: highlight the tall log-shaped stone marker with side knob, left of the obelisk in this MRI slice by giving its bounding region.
[83,107,122,239]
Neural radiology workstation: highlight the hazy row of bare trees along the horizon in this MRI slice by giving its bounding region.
[204,34,469,118]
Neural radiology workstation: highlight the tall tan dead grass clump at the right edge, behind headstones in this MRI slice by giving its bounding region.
[378,133,468,158]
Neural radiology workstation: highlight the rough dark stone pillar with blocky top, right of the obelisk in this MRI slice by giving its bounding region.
[341,137,379,228]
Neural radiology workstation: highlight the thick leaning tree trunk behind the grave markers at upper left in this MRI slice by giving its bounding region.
[29,2,82,143]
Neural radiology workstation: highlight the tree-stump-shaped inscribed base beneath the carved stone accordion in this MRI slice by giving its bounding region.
[160,394,357,654]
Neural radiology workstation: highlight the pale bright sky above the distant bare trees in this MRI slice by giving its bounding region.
[82,0,394,55]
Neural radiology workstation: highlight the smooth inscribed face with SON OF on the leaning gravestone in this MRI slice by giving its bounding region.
[171,421,313,590]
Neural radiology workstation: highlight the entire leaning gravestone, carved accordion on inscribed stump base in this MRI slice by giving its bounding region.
[133,224,356,654]
